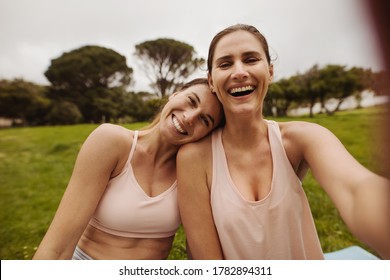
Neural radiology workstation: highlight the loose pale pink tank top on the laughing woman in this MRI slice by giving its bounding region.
[211,121,324,260]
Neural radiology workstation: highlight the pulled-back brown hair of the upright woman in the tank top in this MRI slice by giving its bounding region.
[207,24,271,73]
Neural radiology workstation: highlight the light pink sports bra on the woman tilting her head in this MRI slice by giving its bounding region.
[90,131,181,238]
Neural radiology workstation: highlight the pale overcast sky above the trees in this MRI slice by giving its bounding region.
[0,0,384,90]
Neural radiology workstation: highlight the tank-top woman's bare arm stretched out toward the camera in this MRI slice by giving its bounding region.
[295,124,390,259]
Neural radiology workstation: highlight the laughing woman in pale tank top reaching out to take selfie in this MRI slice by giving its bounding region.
[177,24,390,259]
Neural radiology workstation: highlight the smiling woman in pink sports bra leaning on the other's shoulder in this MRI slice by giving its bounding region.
[34,79,223,259]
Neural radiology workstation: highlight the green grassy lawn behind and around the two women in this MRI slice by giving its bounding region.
[0,108,386,260]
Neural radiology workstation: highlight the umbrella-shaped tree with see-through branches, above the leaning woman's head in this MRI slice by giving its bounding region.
[134,38,204,98]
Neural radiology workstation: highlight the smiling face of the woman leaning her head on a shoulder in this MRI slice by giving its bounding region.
[160,84,223,145]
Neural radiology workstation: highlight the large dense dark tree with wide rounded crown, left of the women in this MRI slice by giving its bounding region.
[45,46,133,122]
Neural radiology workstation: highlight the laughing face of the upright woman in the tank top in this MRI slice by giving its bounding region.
[209,30,273,116]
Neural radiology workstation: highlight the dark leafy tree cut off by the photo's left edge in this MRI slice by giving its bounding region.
[0,79,51,124]
